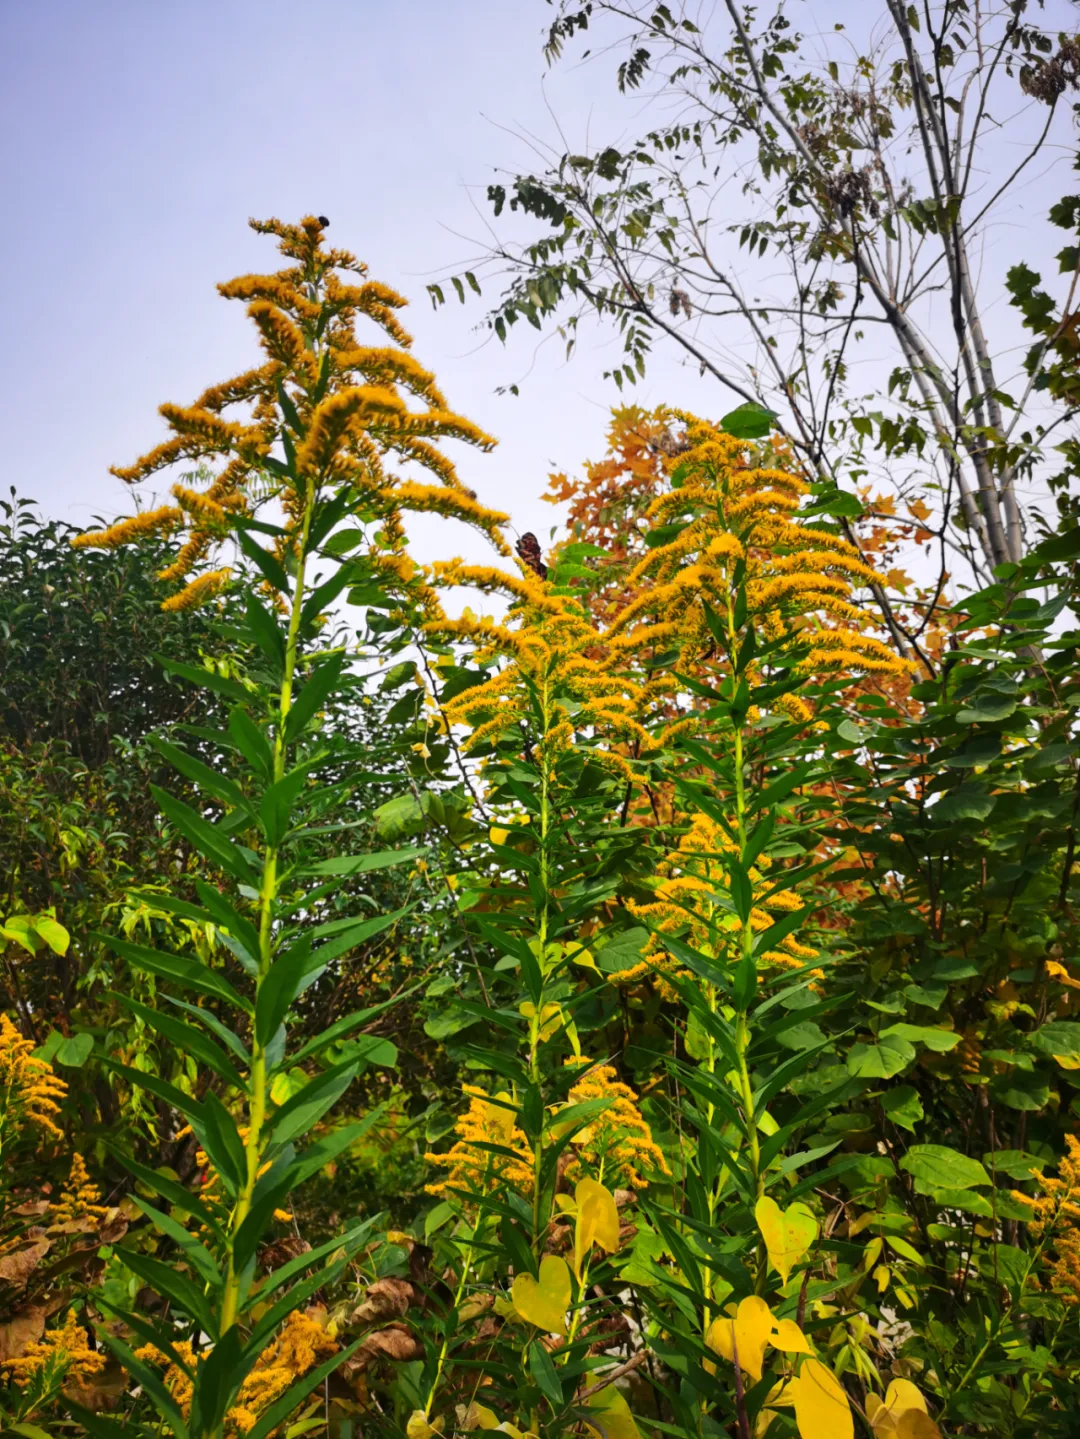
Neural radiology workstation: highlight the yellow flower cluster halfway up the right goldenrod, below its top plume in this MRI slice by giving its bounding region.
[608,813,821,1002]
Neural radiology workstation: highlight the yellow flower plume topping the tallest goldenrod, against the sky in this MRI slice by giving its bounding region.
[75,216,509,610]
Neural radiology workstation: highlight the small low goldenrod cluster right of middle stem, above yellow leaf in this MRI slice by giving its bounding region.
[567,1059,672,1189]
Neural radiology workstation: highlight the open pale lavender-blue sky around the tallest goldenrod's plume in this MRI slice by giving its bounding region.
[0,0,1074,572]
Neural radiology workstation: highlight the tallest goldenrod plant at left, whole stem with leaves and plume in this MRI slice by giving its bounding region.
[70,217,508,1439]
